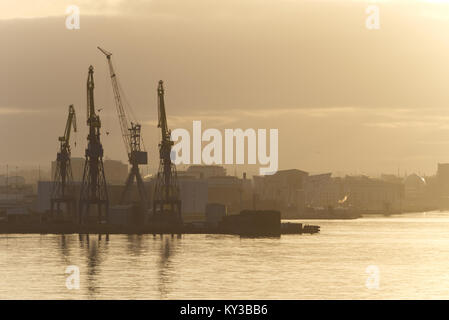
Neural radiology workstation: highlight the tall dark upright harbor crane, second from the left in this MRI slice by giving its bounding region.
[79,66,109,223]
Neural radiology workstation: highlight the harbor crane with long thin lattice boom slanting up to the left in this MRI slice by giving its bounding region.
[97,47,148,213]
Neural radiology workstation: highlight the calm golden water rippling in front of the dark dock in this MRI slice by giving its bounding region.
[0,213,449,299]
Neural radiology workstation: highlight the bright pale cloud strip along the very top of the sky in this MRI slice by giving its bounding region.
[0,0,449,20]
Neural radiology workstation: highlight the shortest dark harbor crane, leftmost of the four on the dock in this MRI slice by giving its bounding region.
[50,105,77,218]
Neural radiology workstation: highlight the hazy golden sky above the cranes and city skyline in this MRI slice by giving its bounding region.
[0,0,449,175]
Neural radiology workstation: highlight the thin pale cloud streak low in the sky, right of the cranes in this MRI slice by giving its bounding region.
[153,107,449,131]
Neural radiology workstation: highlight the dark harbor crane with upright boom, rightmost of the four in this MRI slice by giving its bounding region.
[153,80,182,224]
